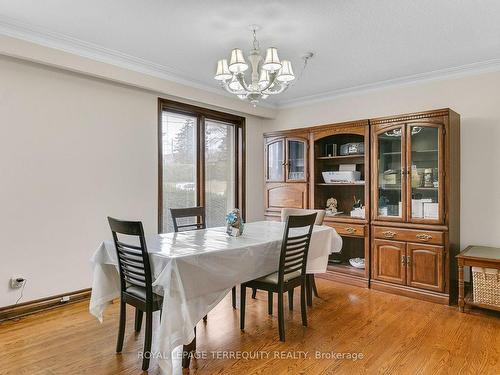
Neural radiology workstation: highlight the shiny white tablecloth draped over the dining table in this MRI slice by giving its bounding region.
[90,221,342,374]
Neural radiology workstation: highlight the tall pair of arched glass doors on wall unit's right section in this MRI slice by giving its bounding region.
[372,120,444,224]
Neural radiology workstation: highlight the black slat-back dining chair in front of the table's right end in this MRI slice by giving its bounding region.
[240,213,317,341]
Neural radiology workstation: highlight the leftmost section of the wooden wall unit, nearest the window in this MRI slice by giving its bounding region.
[264,131,309,220]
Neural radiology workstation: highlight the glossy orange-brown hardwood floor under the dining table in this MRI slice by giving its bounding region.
[0,279,500,375]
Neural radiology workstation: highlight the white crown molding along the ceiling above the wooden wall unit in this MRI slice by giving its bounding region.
[277,59,500,110]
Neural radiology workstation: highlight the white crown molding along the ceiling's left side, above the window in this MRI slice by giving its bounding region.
[0,15,276,109]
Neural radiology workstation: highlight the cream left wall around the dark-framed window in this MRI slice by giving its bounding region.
[0,56,264,306]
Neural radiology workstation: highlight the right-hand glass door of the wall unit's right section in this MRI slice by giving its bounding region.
[407,124,442,221]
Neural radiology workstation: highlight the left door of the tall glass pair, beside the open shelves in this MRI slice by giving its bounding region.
[374,126,406,221]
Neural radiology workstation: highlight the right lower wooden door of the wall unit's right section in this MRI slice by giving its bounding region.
[406,243,444,292]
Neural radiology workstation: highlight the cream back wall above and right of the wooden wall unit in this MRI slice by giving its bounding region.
[264,72,500,248]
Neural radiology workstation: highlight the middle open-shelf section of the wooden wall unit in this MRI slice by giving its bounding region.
[309,121,370,286]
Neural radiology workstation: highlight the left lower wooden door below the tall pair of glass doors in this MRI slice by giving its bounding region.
[372,239,406,285]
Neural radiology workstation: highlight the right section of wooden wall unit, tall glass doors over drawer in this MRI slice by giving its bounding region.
[370,109,460,303]
